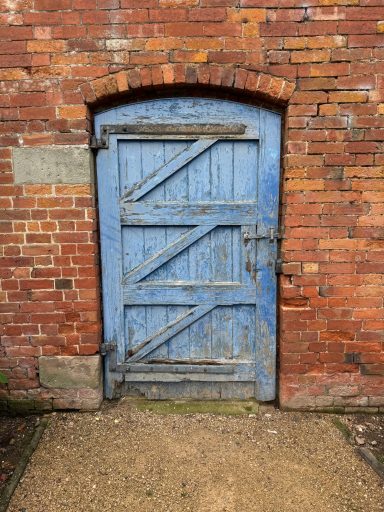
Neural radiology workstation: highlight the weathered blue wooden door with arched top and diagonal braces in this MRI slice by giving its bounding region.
[96,98,280,400]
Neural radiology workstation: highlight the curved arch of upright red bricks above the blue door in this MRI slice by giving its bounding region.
[80,64,296,108]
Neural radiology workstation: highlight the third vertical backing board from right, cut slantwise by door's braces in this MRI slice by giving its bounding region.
[188,146,215,358]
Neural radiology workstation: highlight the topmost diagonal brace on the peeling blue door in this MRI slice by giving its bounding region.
[121,139,217,203]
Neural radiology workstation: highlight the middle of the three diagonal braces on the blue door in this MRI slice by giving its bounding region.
[123,225,216,284]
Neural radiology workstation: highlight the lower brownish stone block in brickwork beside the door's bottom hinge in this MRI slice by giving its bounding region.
[39,355,102,389]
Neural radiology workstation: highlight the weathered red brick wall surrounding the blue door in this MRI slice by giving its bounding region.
[0,0,384,410]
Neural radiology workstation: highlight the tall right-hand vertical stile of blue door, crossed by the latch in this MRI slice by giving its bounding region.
[256,110,281,400]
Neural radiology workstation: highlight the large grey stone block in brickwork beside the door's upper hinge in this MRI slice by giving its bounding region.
[13,146,94,184]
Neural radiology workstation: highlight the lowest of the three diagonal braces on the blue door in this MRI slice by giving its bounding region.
[127,301,215,363]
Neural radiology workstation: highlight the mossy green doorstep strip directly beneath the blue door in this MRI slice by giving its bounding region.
[130,400,259,416]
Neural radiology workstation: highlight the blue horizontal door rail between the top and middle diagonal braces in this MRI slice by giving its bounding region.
[120,201,257,226]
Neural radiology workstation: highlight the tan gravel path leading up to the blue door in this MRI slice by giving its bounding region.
[8,399,384,512]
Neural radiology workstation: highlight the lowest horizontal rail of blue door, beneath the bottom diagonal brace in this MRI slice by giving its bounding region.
[119,362,256,382]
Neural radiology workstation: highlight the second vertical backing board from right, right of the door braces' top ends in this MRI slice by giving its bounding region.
[211,141,236,359]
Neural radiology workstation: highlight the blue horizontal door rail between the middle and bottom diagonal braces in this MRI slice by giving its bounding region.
[123,281,256,306]
